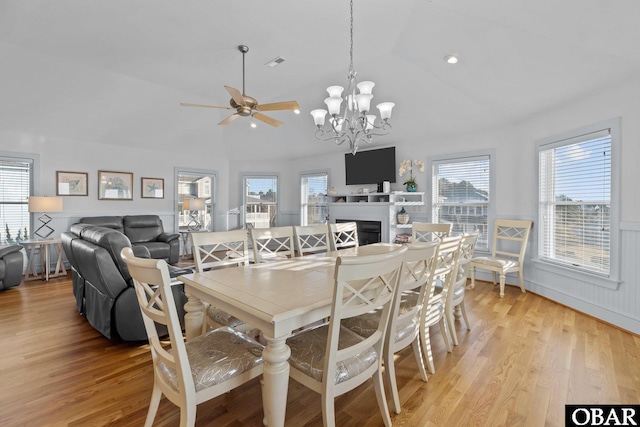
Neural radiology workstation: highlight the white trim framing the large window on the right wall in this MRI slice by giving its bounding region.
[533,117,621,289]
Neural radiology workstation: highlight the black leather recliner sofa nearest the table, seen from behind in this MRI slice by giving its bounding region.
[61,223,191,341]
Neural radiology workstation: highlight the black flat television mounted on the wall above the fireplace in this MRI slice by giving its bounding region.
[344,147,396,185]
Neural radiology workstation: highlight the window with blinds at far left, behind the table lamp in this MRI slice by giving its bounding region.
[0,156,34,244]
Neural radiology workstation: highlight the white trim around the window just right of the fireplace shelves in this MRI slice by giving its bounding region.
[426,148,497,254]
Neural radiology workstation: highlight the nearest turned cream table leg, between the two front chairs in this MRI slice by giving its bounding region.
[262,335,291,427]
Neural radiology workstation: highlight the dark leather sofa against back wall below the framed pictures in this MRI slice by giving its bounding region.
[80,215,180,264]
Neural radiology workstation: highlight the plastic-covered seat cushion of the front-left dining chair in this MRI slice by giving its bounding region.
[159,327,264,391]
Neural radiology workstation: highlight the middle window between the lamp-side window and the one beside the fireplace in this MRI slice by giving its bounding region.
[243,176,278,228]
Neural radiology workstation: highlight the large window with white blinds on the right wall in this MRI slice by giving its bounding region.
[538,123,617,277]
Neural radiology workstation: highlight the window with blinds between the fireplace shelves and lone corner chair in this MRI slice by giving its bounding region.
[431,154,491,250]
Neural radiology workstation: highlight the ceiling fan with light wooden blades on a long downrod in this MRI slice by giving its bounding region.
[180,44,300,127]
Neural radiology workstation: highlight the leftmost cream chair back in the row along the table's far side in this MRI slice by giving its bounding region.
[191,230,249,272]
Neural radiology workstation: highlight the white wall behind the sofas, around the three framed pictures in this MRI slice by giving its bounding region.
[0,132,229,237]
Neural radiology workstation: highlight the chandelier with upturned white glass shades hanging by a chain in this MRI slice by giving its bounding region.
[311,0,395,155]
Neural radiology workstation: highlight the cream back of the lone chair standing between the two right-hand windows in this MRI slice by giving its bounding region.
[492,219,533,265]
